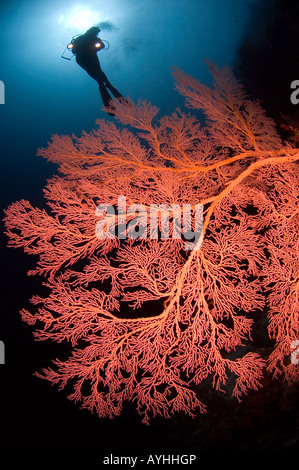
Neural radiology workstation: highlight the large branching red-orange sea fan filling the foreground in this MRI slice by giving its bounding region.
[5,60,299,423]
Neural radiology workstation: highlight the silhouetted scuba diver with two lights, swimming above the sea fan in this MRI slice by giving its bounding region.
[67,26,123,116]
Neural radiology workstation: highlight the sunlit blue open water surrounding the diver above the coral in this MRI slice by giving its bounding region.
[0,0,248,202]
